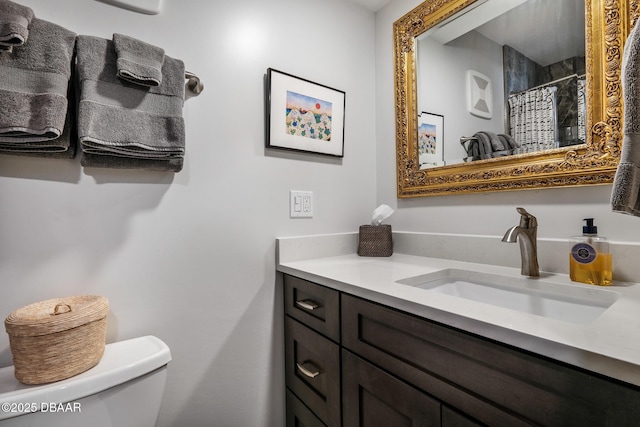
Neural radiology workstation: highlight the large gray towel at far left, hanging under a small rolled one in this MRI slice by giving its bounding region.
[0,18,76,152]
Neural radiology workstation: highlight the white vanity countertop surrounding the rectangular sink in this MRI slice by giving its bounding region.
[277,238,640,386]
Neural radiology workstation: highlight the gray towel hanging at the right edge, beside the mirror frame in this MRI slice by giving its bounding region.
[611,20,640,216]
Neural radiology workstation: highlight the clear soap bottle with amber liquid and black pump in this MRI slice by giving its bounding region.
[569,218,613,286]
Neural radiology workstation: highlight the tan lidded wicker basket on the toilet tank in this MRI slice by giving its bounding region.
[4,295,109,384]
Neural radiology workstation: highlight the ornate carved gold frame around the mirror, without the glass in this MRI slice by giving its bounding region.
[393,0,639,198]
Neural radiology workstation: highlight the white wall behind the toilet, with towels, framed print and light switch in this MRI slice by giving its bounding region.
[0,0,376,426]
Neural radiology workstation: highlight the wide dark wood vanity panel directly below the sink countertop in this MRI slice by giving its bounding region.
[342,295,640,427]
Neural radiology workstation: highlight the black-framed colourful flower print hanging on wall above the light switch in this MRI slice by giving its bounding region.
[267,68,345,157]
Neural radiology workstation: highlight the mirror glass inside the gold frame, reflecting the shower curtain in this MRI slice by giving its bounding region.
[416,0,587,169]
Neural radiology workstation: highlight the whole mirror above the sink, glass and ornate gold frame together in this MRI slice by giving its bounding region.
[393,0,638,198]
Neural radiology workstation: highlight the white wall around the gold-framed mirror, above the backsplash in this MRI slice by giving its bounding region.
[376,0,640,246]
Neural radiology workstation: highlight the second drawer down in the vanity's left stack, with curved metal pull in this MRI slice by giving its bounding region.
[285,316,340,426]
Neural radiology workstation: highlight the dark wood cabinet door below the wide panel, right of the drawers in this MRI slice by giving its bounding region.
[342,350,440,427]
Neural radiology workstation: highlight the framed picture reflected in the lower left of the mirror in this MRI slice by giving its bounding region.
[418,111,444,169]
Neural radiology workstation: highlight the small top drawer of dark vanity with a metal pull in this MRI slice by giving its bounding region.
[284,275,340,342]
